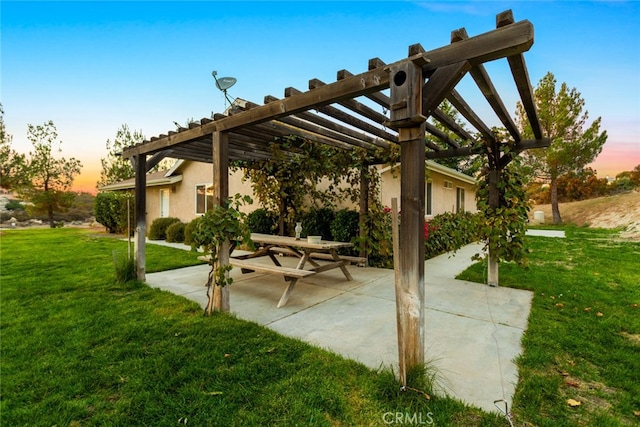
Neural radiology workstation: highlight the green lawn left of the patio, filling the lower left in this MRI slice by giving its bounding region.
[0,228,504,426]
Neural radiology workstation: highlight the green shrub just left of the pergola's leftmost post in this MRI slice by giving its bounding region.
[93,191,135,233]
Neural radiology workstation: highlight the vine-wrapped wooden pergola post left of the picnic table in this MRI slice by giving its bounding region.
[207,132,230,315]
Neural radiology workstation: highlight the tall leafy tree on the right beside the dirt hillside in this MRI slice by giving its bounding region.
[516,72,607,224]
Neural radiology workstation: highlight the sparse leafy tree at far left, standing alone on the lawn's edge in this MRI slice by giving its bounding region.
[18,120,82,227]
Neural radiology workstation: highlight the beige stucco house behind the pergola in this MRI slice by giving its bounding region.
[100,160,476,224]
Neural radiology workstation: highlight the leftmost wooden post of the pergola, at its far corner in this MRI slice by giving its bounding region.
[133,154,147,282]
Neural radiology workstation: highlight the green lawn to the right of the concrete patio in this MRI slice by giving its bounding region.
[459,228,640,426]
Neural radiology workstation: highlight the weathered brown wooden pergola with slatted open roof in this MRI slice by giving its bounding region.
[122,11,549,367]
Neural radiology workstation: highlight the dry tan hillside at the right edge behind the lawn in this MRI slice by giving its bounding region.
[530,191,640,239]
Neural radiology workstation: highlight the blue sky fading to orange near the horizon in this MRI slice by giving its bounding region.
[0,1,640,190]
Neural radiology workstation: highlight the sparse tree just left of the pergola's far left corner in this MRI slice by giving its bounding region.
[97,124,144,187]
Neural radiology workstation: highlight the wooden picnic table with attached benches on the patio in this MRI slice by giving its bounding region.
[229,233,353,308]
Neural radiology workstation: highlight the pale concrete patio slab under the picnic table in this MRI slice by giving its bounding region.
[147,242,532,411]
